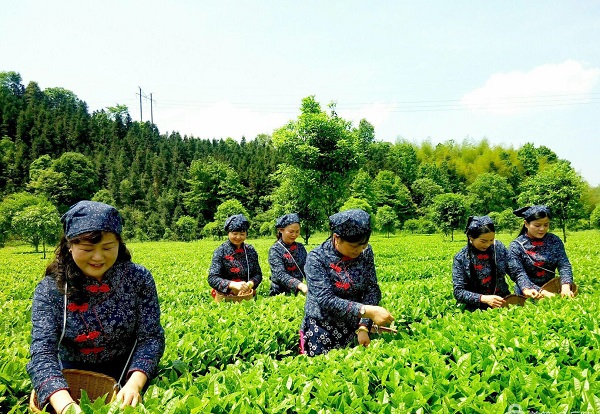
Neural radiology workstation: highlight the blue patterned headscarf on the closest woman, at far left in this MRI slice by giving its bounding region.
[60,200,123,239]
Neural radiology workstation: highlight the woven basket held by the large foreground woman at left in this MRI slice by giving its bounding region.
[29,369,117,413]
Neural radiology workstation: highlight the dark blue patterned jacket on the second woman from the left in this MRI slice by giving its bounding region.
[208,240,262,294]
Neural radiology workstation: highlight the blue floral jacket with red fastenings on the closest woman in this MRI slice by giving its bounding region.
[27,262,165,405]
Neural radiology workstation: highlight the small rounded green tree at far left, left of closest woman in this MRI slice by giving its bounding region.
[13,202,62,259]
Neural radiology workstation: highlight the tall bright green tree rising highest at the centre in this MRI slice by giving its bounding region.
[273,96,369,239]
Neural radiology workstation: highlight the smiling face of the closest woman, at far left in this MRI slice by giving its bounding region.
[70,232,119,280]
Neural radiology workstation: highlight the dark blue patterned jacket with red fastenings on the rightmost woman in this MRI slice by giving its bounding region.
[509,233,573,291]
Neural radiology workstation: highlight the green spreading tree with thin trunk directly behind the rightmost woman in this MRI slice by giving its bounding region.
[519,161,585,242]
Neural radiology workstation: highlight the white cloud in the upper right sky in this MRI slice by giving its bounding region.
[462,60,600,115]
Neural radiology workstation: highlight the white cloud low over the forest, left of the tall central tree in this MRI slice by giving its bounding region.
[154,101,293,140]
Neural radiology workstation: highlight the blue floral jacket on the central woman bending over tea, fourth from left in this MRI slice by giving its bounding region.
[303,239,381,330]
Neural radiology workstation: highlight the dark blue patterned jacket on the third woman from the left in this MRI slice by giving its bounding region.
[269,239,306,295]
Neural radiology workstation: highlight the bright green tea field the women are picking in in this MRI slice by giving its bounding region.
[0,231,600,413]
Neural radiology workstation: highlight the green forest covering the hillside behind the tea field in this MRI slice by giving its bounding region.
[0,72,600,248]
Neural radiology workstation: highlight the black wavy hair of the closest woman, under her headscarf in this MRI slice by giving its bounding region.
[46,230,131,304]
